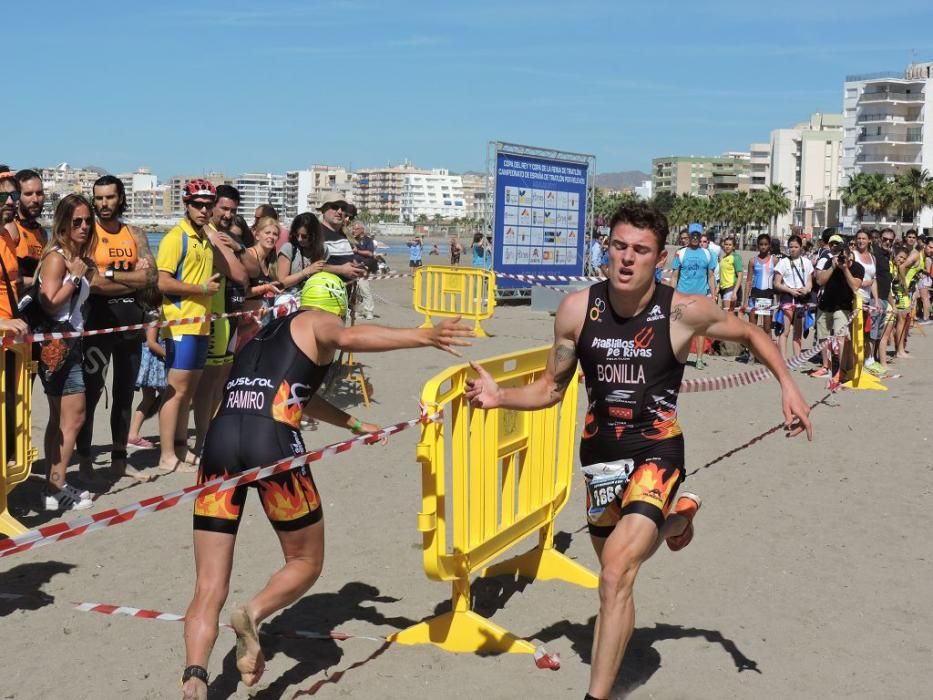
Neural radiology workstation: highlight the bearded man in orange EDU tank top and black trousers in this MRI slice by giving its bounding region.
[77,175,158,481]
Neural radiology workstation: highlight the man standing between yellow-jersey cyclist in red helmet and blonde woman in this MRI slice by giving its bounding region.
[194,185,249,455]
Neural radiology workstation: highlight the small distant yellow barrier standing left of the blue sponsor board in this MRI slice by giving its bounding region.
[412,265,496,338]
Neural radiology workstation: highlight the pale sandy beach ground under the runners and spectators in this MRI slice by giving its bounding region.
[0,257,933,700]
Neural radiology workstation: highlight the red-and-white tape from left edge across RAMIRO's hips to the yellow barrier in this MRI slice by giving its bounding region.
[0,409,442,558]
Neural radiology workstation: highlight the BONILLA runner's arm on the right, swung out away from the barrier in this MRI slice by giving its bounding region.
[671,295,813,440]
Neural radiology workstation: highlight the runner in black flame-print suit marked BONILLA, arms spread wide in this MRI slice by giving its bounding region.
[466,204,812,700]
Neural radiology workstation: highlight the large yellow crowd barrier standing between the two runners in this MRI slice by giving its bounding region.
[390,347,599,654]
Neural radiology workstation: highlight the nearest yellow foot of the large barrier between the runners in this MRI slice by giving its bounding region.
[388,579,535,654]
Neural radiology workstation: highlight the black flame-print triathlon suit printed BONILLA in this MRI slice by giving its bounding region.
[576,281,684,537]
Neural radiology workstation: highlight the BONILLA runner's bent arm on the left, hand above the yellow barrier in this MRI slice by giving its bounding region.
[466,290,588,411]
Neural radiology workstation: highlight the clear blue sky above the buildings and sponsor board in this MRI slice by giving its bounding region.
[7,0,933,178]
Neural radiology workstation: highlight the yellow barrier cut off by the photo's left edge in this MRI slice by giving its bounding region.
[0,345,37,537]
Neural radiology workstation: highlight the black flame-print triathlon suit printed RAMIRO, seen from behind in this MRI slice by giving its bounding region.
[194,311,330,534]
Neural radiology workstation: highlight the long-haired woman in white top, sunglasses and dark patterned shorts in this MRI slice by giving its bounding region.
[37,194,97,510]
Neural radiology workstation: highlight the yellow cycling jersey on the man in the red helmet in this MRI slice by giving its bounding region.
[156,219,214,338]
